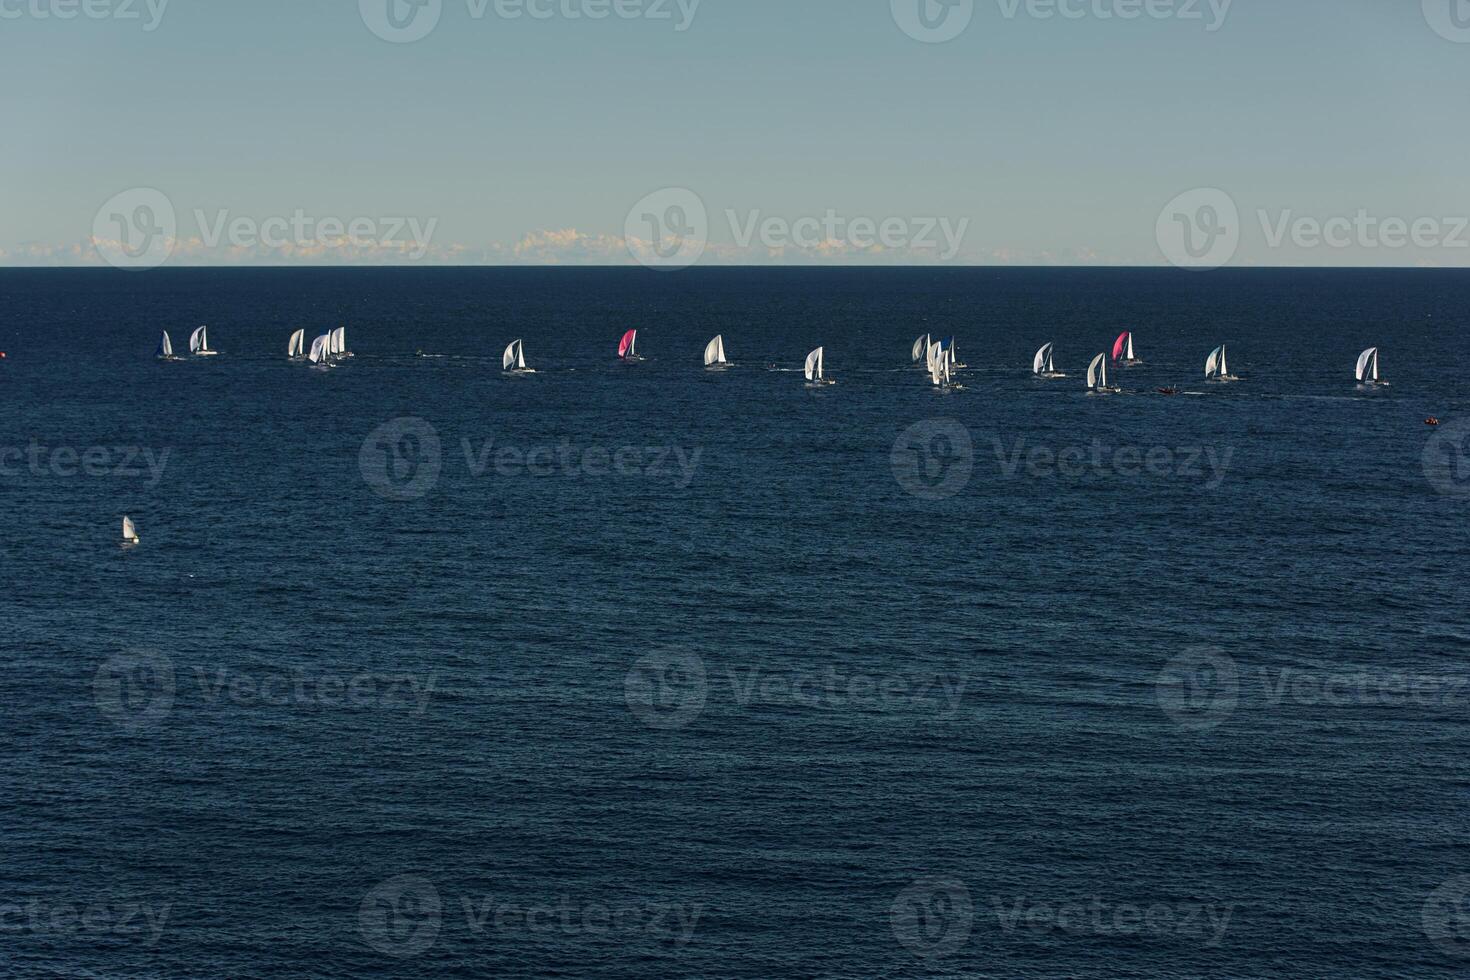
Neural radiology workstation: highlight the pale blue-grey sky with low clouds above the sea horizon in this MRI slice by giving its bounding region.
[0,0,1470,269]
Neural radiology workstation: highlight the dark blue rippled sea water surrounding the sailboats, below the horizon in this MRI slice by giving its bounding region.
[0,264,1470,977]
